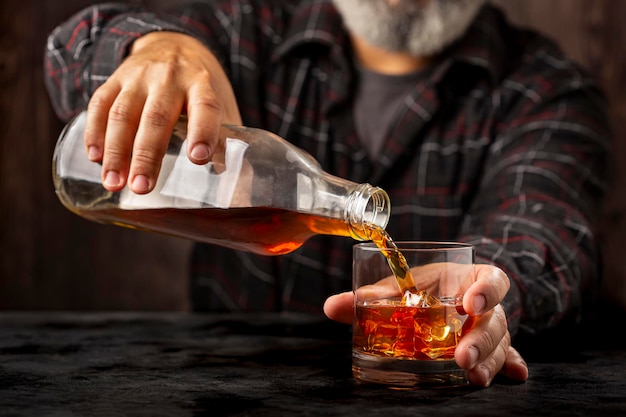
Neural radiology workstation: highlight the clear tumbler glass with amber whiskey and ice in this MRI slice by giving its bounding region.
[352,241,474,388]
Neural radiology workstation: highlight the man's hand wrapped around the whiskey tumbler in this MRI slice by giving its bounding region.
[324,264,528,387]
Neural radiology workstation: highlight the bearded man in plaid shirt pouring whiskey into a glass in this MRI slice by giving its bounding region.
[46,0,609,386]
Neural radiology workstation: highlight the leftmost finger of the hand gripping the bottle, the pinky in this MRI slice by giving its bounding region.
[84,82,120,162]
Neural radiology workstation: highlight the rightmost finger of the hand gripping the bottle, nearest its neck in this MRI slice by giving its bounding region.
[187,84,224,164]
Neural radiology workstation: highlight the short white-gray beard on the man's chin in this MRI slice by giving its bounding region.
[333,0,486,56]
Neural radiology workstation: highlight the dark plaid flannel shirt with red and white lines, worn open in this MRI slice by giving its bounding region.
[46,0,610,334]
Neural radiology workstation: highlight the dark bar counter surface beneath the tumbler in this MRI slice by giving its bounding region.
[0,312,626,417]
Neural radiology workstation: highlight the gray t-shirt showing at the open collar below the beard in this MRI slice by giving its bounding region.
[352,67,423,161]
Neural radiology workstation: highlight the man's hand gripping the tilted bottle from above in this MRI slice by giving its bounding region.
[85,32,241,194]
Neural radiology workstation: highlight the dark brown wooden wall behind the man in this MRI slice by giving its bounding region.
[0,0,626,310]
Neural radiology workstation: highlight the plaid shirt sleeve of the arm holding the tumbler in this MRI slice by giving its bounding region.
[460,57,611,335]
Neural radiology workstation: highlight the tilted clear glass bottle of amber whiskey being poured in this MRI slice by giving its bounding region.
[52,112,390,255]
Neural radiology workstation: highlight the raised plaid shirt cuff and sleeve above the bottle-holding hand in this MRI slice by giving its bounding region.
[44,3,208,120]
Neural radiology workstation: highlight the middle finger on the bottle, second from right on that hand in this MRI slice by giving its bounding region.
[128,100,182,194]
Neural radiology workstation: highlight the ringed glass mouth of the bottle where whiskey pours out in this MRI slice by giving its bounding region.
[345,184,391,240]
